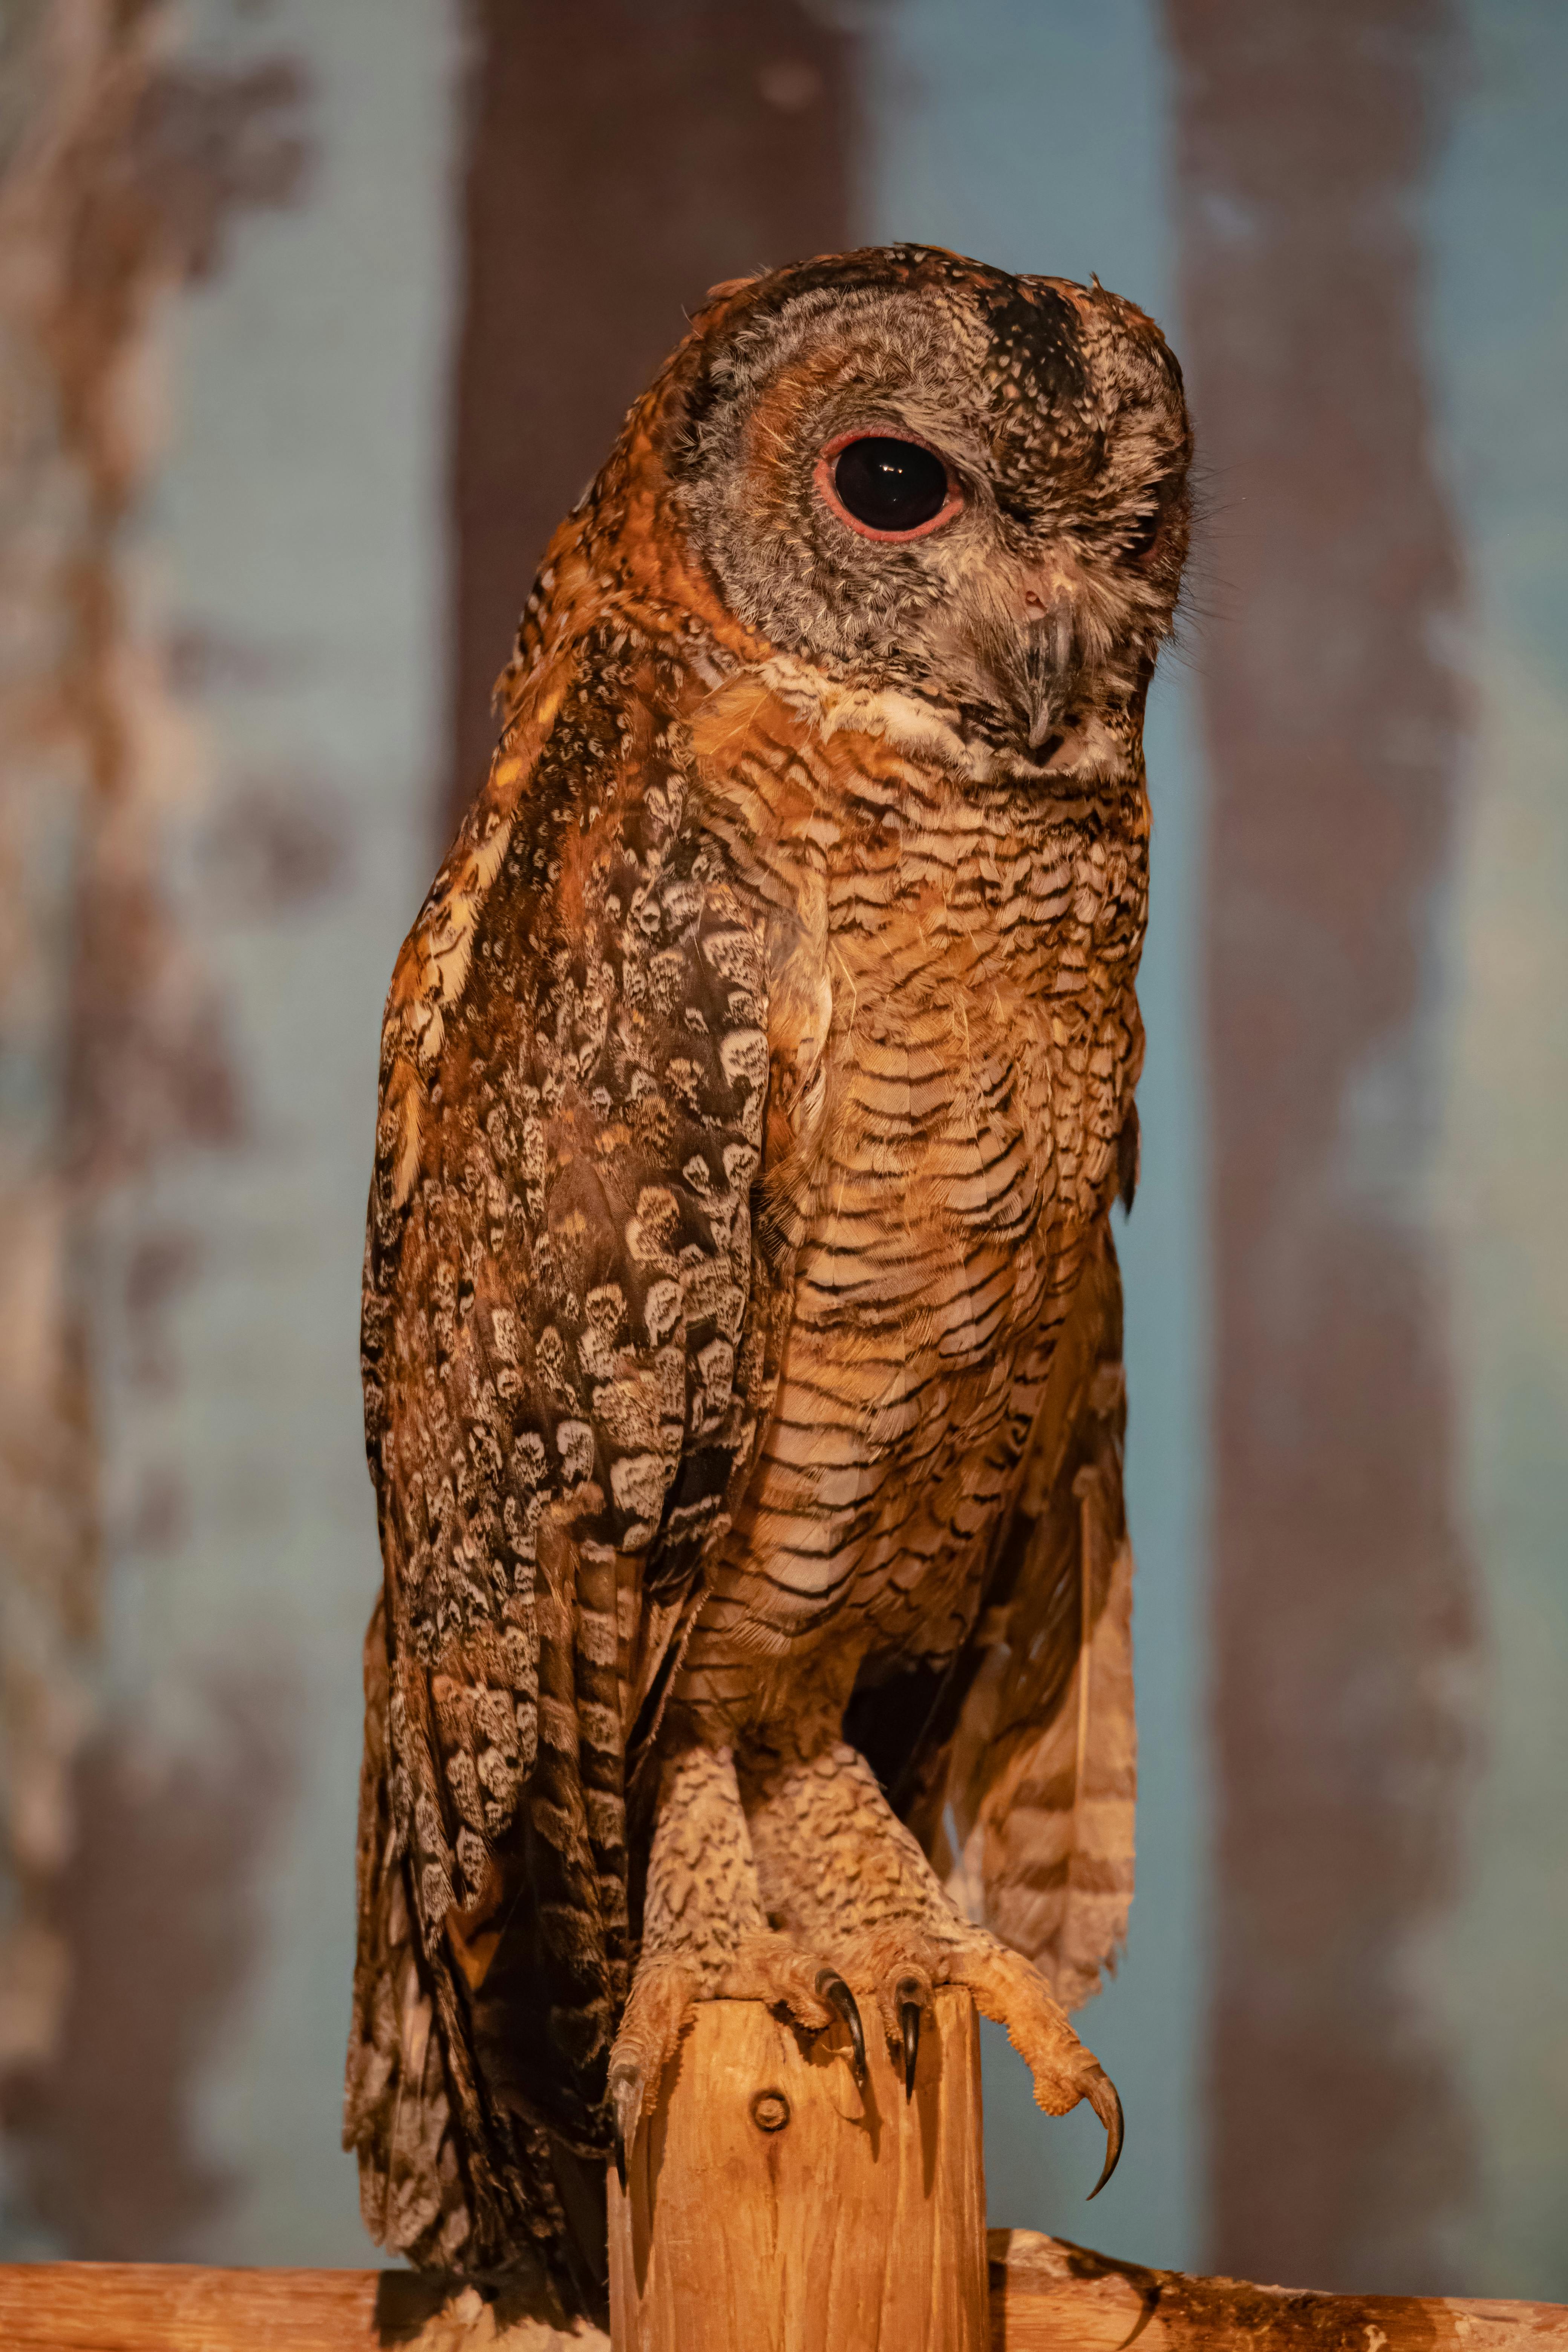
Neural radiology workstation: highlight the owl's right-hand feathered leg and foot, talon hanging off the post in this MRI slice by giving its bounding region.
[743,1743,1121,2197]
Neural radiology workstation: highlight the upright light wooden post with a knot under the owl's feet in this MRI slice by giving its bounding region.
[609,1990,990,2352]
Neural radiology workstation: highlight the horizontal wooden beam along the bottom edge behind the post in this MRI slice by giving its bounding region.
[0,2230,1568,2352]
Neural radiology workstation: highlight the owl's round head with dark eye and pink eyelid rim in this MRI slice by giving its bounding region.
[665,247,1192,764]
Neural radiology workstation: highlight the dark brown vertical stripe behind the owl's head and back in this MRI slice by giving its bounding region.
[442,0,849,828]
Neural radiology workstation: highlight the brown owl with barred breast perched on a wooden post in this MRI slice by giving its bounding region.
[346,247,1192,2310]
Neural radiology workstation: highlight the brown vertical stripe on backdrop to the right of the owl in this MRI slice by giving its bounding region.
[1166,0,1472,2291]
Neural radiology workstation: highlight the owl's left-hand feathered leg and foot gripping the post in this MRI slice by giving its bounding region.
[609,1747,865,2187]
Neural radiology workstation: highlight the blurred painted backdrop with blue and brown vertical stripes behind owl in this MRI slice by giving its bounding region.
[0,0,1568,2298]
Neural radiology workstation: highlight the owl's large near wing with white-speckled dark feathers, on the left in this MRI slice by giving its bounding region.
[348,698,771,2300]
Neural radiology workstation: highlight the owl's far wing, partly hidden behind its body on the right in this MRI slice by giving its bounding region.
[884,1228,1138,2009]
